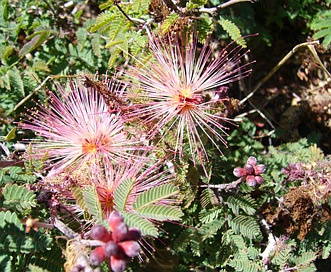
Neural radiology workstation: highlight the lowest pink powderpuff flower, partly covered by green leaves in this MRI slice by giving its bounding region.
[92,153,179,218]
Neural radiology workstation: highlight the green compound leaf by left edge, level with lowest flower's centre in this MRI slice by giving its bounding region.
[3,184,37,213]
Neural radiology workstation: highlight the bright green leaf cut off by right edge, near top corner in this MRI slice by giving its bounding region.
[310,10,331,48]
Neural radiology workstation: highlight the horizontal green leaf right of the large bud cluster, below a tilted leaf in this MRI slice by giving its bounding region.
[138,204,183,221]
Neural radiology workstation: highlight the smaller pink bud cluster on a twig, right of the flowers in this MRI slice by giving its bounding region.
[233,156,266,186]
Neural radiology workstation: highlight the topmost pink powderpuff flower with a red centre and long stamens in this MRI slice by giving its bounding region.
[127,31,251,170]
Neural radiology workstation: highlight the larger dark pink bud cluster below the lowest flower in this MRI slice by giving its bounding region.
[90,211,141,272]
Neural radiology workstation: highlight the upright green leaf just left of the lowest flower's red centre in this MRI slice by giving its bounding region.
[83,185,103,221]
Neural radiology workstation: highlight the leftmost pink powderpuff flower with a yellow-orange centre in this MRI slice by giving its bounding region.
[20,79,138,175]
